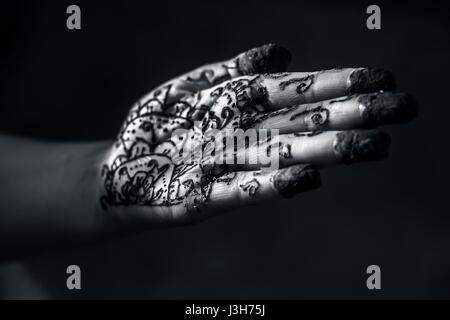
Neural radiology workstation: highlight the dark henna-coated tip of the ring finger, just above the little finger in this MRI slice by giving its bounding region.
[334,130,391,164]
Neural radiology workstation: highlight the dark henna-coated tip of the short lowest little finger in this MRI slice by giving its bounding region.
[273,165,321,198]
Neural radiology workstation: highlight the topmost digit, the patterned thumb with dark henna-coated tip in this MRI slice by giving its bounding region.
[163,44,291,99]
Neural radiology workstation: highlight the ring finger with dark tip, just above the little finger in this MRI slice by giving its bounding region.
[229,130,390,171]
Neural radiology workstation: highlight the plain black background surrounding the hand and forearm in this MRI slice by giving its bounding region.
[0,0,450,299]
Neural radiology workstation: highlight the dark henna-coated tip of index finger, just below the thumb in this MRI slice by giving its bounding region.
[347,68,396,94]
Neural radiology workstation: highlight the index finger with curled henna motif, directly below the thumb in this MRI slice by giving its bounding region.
[195,68,395,111]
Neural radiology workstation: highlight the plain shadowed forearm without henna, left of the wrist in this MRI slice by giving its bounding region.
[0,135,112,259]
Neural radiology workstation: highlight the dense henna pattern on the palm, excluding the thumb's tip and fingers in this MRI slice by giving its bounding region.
[100,70,267,212]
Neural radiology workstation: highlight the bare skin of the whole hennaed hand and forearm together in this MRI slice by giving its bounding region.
[0,45,417,258]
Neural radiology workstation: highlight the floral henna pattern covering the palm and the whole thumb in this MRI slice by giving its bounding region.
[101,45,301,212]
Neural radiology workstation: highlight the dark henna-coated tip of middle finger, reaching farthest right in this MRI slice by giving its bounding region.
[358,92,419,128]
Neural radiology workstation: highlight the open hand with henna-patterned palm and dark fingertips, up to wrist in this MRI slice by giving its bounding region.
[101,45,417,225]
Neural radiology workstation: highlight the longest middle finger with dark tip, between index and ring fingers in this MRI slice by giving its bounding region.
[241,92,418,134]
